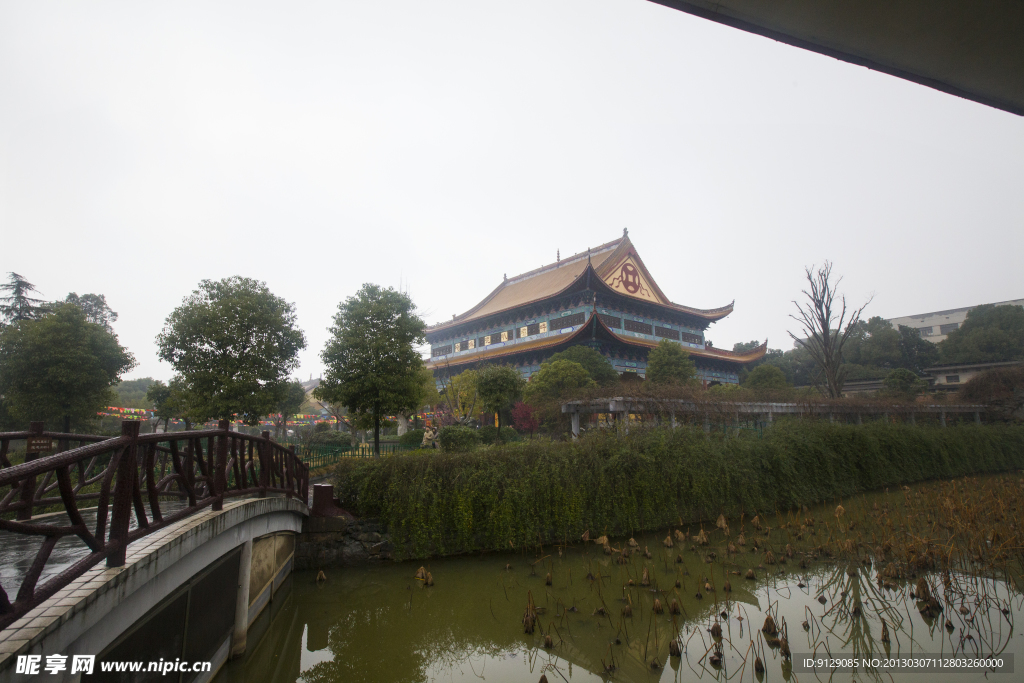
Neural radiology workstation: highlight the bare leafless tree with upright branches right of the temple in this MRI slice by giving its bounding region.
[790,261,871,398]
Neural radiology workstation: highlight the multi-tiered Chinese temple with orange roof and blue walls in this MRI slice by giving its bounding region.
[419,230,768,387]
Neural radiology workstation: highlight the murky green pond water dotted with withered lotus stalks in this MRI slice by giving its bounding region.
[217,481,1024,683]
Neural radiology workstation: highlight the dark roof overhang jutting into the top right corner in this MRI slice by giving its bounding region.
[653,0,1024,116]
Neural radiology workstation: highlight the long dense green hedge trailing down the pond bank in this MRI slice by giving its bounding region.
[335,421,1024,556]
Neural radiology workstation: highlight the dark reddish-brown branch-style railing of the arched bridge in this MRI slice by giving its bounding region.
[0,420,309,629]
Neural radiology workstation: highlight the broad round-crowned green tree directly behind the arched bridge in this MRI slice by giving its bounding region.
[151,275,306,425]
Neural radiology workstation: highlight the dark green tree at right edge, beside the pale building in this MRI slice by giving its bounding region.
[938,304,1024,364]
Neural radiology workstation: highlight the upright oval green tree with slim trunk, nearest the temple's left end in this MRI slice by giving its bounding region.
[315,285,426,456]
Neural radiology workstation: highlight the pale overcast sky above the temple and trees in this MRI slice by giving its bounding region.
[0,0,1024,379]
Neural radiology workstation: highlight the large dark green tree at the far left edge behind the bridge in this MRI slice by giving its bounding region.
[0,304,135,432]
